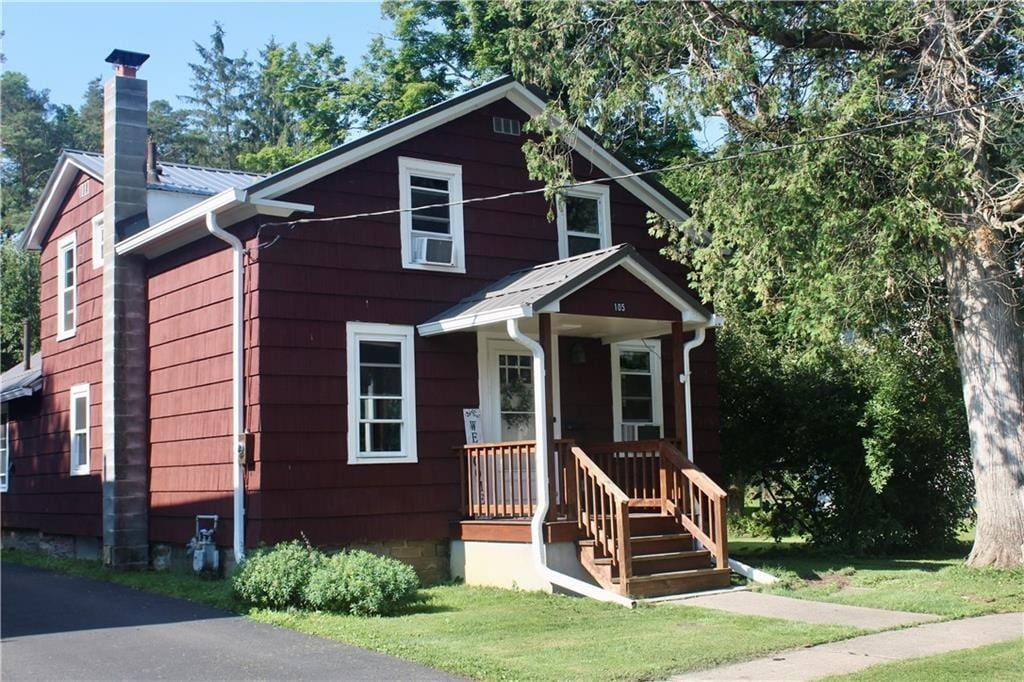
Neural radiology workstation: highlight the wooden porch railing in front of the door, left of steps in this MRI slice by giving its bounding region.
[457,440,574,518]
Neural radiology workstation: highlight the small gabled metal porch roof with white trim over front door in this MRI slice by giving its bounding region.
[417,244,712,336]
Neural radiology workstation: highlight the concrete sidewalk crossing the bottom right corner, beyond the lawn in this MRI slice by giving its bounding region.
[673,613,1024,682]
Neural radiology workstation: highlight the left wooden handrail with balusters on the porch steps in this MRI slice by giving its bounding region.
[569,445,633,594]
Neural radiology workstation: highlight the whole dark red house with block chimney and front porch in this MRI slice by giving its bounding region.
[0,51,728,598]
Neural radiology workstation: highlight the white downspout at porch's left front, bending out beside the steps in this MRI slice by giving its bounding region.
[507,319,636,608]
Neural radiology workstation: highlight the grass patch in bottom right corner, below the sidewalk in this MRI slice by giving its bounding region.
[828,639,1024,682]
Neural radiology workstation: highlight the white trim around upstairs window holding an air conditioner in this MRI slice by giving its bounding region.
[398,157,466,273]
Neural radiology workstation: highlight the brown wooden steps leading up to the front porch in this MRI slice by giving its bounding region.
[578,511,729,597]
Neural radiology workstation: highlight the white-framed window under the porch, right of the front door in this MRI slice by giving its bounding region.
[611,341,664,440]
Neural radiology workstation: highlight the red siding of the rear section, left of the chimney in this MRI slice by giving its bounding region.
[0,174,103,536]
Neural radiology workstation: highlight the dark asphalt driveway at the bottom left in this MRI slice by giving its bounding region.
[0,564,453,682]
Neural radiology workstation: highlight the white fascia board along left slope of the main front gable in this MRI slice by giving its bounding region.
[252,83,522,199]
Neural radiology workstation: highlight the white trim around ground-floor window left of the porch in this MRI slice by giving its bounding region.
[345,322,418,464]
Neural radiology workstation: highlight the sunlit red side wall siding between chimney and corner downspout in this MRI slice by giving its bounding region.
[148,238,232,545]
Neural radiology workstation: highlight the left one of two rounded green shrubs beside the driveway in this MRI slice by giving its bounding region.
[232,540,326,608]
